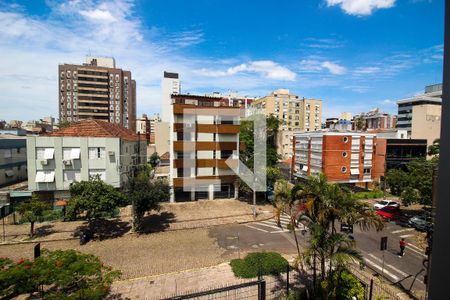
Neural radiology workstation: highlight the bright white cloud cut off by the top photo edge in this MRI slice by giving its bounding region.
[326,0,395,16]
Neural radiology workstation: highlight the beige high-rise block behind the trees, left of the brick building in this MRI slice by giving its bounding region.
[252,89,322,131]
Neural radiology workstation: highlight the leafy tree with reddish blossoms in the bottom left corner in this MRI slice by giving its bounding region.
[0,249,120,299]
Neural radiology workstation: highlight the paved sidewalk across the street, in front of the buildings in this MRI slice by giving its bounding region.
[0,199,273,245]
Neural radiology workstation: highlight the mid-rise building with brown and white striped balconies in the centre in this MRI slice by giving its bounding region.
[170,95,243,202]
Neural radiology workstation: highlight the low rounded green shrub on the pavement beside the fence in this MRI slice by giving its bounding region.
[230,252,289,278]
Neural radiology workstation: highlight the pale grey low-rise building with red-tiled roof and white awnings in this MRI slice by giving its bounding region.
[27,120,146,199]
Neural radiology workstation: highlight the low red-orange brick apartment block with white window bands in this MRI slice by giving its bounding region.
[293,132,386,187]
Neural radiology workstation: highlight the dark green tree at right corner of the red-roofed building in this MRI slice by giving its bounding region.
[129,172,170,231]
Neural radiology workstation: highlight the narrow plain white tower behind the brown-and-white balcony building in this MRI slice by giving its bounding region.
[161,71,181,123]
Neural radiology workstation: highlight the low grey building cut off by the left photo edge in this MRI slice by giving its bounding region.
[0,135,27,187]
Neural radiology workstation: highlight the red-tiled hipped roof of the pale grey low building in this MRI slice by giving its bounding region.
[43,119,145,141]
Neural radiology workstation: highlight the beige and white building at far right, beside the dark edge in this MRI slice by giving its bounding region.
[397,84,442,145]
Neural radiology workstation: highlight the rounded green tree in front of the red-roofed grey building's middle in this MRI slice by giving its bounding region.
[67,176,127,221]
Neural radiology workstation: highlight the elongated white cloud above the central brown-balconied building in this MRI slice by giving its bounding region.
[196,60,296,81]
